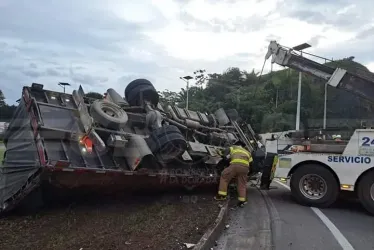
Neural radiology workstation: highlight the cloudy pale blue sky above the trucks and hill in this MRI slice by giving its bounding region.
[0,0,374,104]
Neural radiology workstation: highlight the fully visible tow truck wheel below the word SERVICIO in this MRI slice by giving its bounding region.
[290,164,339,208]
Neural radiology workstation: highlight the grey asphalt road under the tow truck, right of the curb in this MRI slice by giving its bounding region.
[216,183,374,250]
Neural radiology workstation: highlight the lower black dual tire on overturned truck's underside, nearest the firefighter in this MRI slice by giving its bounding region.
[147,125,187,162]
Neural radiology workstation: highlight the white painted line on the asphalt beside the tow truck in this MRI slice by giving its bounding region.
[275,180,355,250]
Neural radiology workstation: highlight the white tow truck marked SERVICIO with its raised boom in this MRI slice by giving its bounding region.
[265,41,374,214]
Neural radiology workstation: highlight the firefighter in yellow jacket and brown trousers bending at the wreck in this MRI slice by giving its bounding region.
[214,141,253,207]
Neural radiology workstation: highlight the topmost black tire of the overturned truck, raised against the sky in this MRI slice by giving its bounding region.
[125,79,159,106]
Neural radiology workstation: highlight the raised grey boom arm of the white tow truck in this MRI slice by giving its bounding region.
[265,41,374,103]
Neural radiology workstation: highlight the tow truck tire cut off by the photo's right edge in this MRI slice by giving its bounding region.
[357,171,374,215]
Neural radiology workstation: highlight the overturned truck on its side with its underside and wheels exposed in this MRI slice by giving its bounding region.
[0,79,264,212]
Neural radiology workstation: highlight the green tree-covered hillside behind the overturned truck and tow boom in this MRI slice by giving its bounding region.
[160,59,373,132]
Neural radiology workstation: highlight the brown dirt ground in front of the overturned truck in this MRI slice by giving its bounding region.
[0,190,220,250]
